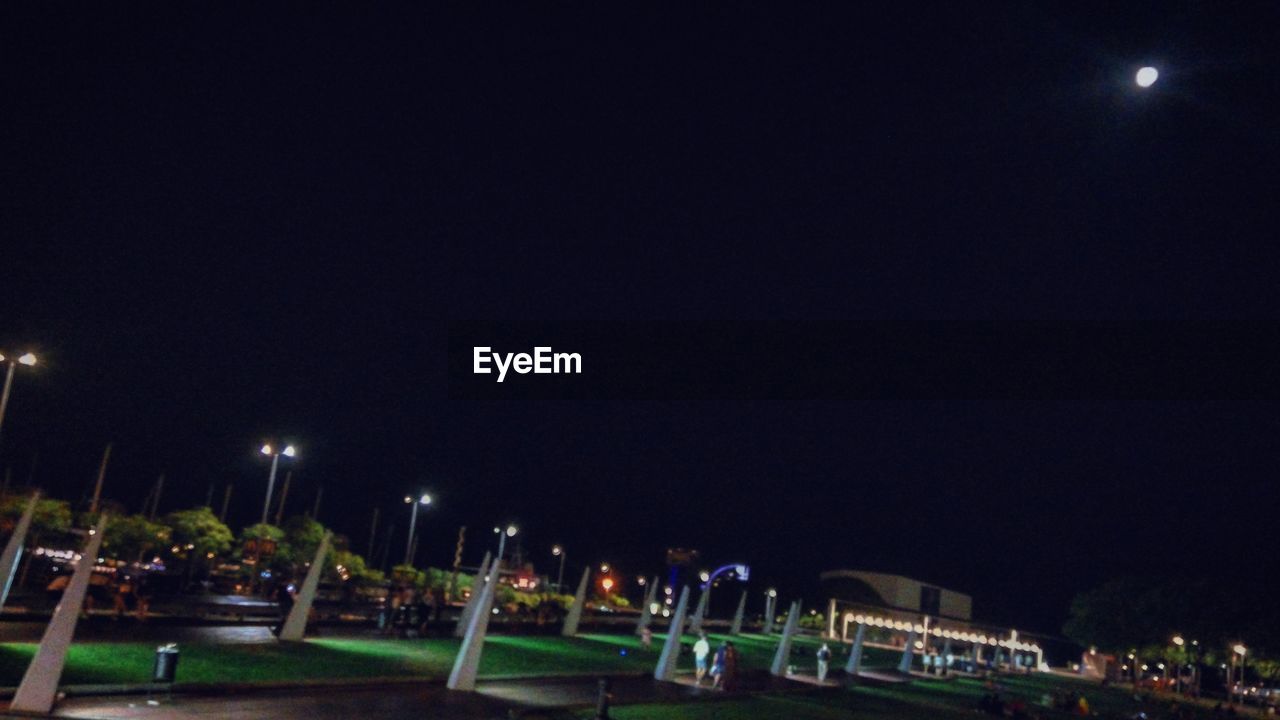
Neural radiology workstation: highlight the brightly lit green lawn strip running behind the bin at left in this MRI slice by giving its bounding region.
[0,634,892,687]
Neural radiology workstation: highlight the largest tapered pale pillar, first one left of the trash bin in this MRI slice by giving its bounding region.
[9,512,106,714]
